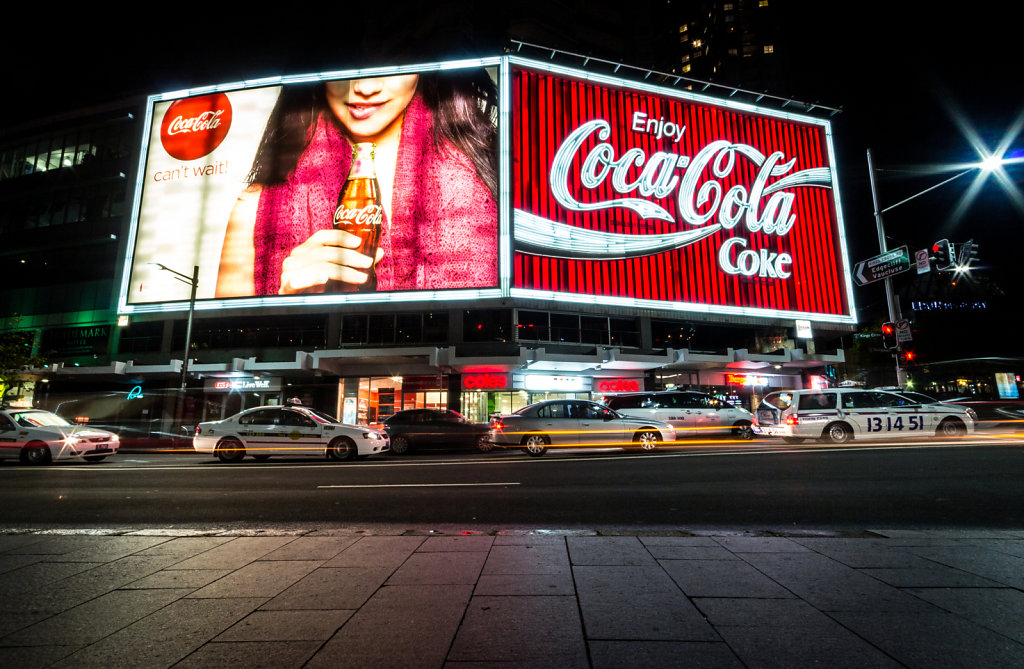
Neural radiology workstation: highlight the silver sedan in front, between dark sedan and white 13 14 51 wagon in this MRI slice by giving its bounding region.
[490,400,676,456]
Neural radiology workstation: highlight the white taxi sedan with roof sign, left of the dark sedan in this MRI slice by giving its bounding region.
[193,406,389,462]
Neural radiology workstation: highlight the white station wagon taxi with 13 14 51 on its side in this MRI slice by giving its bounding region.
[754,388,978,444]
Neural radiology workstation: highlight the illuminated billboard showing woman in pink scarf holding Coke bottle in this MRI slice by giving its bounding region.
[119,58,501,313]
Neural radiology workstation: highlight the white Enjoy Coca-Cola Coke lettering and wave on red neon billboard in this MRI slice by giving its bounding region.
[515,112,833,279]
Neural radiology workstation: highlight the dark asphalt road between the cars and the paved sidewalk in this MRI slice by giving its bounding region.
[0,435,1024,532]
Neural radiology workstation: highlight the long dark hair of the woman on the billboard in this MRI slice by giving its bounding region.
[249,69,498,197]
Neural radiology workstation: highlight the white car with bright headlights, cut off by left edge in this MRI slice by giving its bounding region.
[0,409,119,464]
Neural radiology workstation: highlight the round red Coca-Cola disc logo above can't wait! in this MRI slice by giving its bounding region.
[160,93,231,160]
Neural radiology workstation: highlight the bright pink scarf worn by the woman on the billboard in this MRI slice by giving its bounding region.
[253,95,498,295]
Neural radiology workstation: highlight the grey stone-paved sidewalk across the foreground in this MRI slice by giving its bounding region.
[0,529,1024,669]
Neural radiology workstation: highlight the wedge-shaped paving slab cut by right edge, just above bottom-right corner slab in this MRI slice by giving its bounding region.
[908,588,1024,643]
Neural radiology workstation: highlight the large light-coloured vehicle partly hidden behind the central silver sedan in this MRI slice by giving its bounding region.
[605,390,754,440]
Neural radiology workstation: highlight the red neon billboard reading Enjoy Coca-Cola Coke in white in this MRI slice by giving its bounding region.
[509,57,855,324]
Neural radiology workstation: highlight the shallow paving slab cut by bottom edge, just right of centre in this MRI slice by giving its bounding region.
[589,640,743,669]
